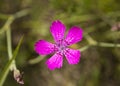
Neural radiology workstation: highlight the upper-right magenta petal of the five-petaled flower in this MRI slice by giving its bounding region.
[65,26,83,45]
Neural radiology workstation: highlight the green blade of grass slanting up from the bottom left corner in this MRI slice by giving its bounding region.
[0,37,23,86]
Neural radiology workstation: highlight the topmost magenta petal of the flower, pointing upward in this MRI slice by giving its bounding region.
[50,20,66,42]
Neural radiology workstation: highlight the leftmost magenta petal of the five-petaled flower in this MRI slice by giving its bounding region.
[34,40,56,55]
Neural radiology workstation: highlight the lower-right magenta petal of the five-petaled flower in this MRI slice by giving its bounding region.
[64,48,80,64]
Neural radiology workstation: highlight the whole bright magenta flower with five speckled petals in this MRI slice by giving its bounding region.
[34,20,83,70]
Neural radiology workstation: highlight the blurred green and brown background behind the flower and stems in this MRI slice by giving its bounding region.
[0,0,120,86]
